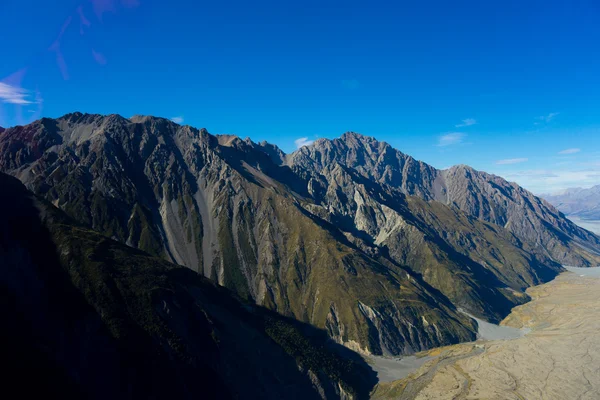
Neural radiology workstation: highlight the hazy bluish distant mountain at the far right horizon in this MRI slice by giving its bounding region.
[542,185,600,220]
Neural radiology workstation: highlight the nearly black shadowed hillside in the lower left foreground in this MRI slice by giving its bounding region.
[0,174,376,399]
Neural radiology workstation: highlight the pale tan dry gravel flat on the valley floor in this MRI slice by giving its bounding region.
[373,272,600,400]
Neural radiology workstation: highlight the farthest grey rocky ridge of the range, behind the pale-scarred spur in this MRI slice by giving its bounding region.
[285,133,600,266]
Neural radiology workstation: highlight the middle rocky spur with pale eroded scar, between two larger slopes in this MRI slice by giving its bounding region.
[284,155,560,321]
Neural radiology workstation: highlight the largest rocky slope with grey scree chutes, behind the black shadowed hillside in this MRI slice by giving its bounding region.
[0,113,478,354]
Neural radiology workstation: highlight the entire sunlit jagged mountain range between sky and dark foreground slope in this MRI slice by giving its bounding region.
[0,113,600,355]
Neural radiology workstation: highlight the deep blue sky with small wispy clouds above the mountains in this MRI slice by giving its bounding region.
[0,0,600,193]
